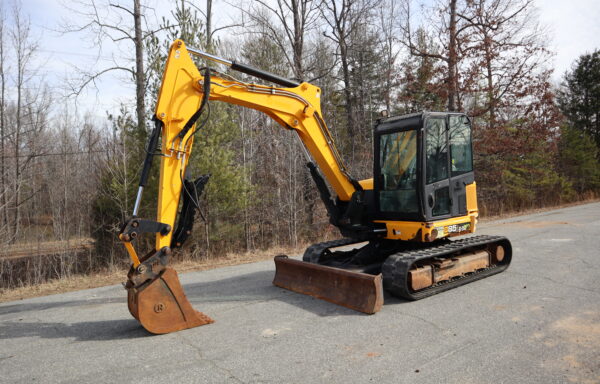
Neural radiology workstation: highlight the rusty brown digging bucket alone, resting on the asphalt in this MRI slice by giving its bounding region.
[127,268,214,334]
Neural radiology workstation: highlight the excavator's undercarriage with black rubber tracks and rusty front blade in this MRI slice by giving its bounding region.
[274,236,512,313]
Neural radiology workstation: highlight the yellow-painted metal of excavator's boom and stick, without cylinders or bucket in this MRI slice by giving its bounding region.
[156,40,360,249]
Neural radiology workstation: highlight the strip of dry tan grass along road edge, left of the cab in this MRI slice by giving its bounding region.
[0,244,307,303]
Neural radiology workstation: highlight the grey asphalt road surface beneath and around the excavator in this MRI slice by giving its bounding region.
[0,203,600,384]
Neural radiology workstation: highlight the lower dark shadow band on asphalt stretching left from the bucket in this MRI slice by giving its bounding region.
[0,318,149,341]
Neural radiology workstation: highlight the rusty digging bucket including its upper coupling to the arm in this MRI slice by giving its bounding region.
[125,249,214,334]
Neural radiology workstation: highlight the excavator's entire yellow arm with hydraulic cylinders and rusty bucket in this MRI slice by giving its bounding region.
[119,40,381,333]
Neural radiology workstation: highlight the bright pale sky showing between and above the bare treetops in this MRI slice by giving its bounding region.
[7,0,600,118]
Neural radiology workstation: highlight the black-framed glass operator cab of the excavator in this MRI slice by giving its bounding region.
[374,112,474,221]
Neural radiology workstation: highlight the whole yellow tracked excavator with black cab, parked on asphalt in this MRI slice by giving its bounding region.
[119,40,512,334]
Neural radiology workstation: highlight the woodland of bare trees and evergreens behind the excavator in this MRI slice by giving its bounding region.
[0,0,600,289]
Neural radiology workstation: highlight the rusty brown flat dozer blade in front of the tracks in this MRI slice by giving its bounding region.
[273,255,383,314]
